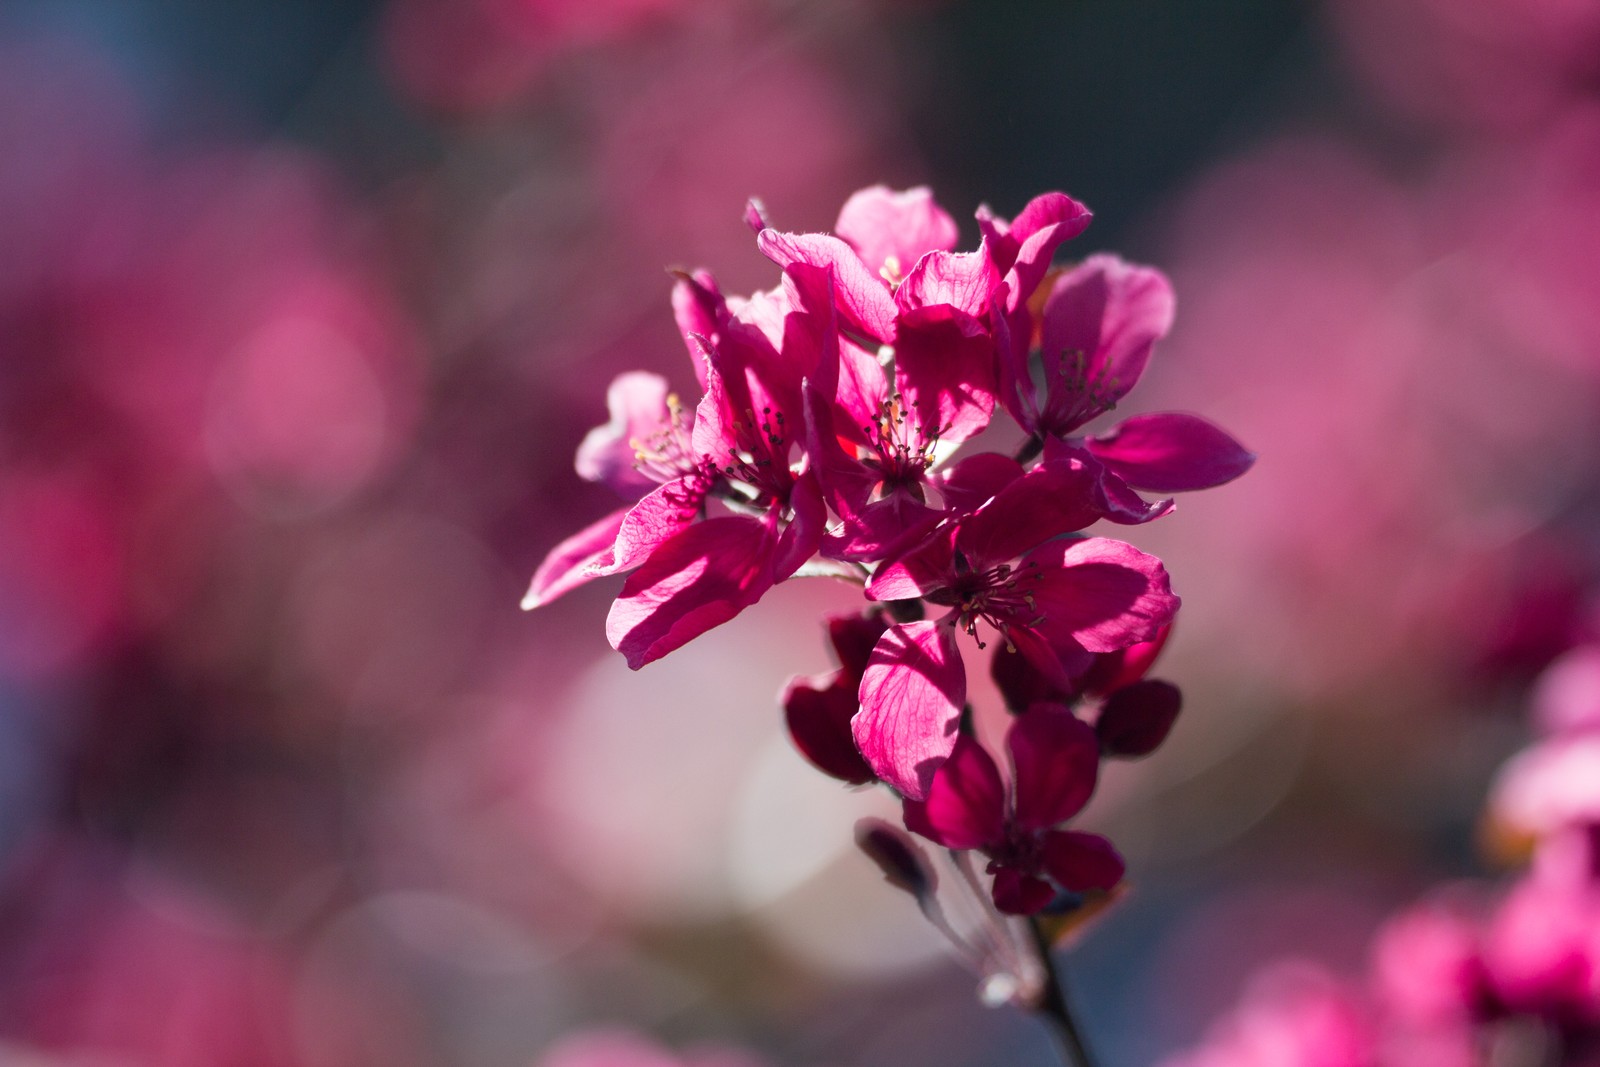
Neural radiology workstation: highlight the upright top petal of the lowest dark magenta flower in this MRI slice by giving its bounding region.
[1006,704,1099,832]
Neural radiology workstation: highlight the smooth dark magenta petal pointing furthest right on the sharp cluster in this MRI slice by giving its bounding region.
[1085,411,1256,493]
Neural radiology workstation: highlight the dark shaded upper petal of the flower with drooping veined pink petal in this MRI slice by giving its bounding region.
[955,464,1101,571]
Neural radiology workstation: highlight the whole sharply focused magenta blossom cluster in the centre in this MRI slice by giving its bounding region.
[525,187,1254,913]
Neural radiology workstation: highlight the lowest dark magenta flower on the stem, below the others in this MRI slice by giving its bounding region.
[906,704,1123,915]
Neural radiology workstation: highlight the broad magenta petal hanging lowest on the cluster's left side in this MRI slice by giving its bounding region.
[605,515,773,670]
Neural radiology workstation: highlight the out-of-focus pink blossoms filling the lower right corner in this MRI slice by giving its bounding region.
[1165,646,1600,1067]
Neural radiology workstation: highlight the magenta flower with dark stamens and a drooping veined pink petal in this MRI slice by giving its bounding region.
[851,466,1179,798]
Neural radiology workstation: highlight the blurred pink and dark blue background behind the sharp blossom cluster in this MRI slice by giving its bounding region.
[0,0,1600,1067]
